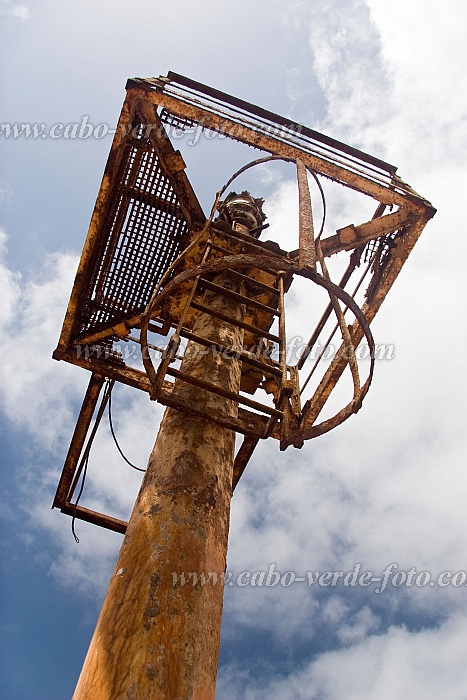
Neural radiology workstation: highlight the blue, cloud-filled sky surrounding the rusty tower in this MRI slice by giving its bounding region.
[0,0,467,700]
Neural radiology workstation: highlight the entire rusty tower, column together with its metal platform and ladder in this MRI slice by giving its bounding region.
[53,72,435,700]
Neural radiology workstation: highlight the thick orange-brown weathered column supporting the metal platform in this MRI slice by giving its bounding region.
[73,273,244,700]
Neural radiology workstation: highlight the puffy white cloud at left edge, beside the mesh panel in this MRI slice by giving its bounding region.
[0,234,85,448]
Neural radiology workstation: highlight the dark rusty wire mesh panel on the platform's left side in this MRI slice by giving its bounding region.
[80,123,188,334]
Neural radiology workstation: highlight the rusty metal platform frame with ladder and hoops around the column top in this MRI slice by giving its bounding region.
[53,72,435,533]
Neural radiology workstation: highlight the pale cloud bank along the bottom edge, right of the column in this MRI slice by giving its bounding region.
[217,615,467,700]
